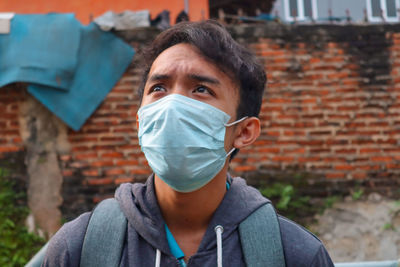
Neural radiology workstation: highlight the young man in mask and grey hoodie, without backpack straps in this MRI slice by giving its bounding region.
[44,21,333,267]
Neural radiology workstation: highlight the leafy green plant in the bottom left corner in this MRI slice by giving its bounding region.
[0,168,45,267]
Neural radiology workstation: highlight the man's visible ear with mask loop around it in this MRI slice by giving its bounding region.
[233,117,261,149]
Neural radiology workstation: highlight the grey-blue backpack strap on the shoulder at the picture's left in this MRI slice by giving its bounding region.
[80,198,127,267]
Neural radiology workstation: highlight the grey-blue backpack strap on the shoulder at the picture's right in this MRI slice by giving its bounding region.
[239,203,285,267]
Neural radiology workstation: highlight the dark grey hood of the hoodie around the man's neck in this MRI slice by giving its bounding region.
[115,175,269,255]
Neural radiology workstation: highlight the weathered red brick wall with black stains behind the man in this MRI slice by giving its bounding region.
[0,24,400,218]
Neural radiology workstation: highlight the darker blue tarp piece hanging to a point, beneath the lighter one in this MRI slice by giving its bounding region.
[28,23,135,130]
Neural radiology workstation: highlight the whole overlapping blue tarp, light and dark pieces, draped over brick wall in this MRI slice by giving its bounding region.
[0,14,135,130]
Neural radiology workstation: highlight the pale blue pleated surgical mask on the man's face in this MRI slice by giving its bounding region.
[138,94,247,192]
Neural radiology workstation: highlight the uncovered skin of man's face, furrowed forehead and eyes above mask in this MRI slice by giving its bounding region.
[141,44,239,151]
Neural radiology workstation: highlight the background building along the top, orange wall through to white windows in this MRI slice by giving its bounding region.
[0,0,400,24]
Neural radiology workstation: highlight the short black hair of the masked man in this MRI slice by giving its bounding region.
[139,20,267,119]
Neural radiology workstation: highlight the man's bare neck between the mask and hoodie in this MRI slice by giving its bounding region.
[154,164,227,232]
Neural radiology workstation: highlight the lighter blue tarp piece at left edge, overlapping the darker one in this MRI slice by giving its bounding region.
[0,14,81,90]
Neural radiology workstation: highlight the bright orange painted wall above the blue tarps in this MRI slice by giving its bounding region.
[0,0,209,24]
